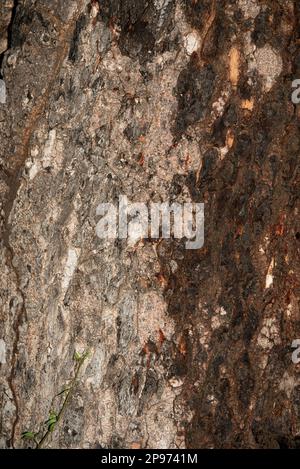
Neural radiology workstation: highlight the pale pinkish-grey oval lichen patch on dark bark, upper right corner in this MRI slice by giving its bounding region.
[254,44,283,91]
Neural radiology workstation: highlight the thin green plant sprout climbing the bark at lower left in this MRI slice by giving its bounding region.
[21,350,89,449]
